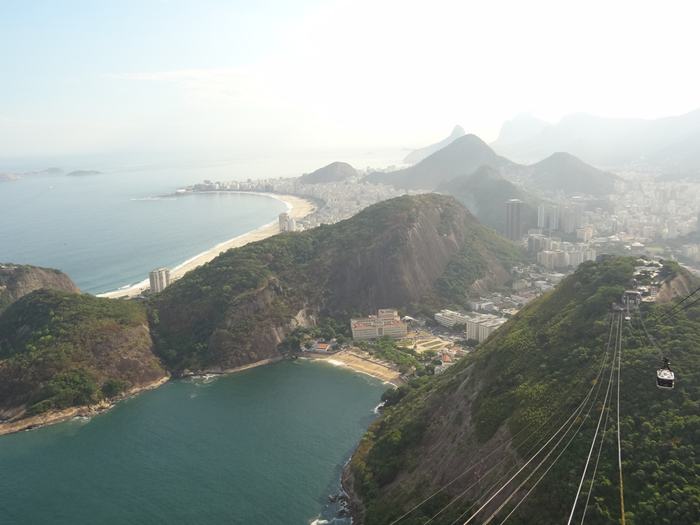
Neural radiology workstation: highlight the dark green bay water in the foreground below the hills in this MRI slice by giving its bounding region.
[0,361,385,525]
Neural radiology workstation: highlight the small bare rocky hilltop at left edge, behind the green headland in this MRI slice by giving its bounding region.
[0,264,80,312]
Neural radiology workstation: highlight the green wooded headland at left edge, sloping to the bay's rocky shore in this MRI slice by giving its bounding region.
[0,289,166,424]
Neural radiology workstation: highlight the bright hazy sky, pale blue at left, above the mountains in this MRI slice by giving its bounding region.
[0,0,700,157]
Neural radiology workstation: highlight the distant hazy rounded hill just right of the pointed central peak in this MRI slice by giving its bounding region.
[527,152,620,195]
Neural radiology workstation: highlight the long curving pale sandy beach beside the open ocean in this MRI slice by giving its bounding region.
[98,192,316,299]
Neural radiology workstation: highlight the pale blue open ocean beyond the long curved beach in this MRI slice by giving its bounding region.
[0,170,286,293]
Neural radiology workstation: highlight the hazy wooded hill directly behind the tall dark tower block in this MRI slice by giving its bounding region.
[437,166,539,232]
